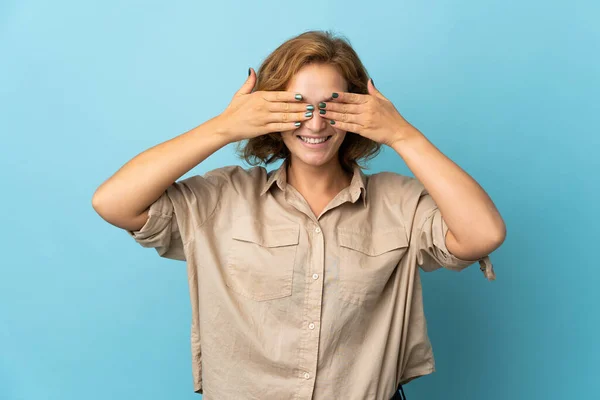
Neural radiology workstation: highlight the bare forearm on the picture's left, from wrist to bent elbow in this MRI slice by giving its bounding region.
[92,118,230,226]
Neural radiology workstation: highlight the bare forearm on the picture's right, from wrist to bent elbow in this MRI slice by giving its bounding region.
[391,126,506,251]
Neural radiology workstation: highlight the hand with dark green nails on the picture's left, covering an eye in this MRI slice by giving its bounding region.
[216,69,314,142]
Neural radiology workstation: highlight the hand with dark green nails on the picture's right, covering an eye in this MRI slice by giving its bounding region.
[319,79,412,146]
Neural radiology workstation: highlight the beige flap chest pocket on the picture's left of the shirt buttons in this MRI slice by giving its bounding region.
[226,218,300,301]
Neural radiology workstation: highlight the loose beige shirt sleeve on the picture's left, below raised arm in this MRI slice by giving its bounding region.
[126,171,226,261]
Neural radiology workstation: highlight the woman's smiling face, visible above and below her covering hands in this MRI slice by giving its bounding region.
[281,64,347,166]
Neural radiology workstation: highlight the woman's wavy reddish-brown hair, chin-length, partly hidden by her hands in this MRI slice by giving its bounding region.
[237,31,381,171]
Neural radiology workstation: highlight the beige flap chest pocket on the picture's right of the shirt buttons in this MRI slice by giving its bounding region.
[338,227,408,305]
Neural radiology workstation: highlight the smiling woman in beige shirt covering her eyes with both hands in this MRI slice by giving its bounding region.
[93,31,505,400]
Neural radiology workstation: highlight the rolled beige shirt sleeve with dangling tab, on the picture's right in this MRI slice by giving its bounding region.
[411,188,496,280]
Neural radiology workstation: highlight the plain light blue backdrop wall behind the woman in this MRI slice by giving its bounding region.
[0,0,600,400]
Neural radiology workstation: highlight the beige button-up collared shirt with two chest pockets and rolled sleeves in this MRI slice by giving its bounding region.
[127,162,494,400]
